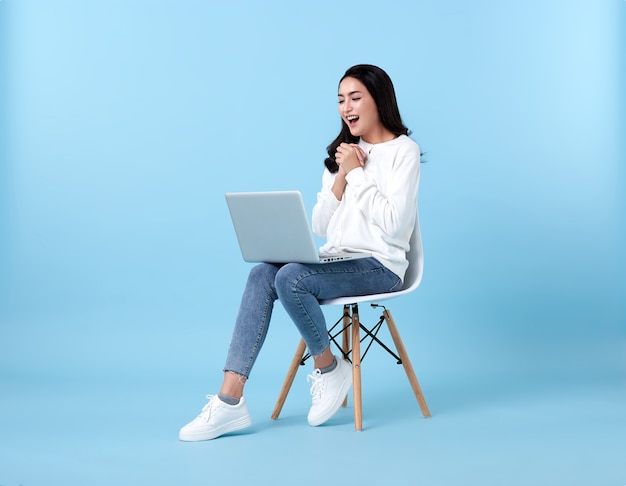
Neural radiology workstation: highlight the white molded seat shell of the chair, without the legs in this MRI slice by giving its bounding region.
[320,216,424,305]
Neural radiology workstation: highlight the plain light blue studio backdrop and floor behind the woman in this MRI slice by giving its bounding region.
[0,0,626,486]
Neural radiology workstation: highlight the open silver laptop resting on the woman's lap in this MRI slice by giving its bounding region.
[226,191,371,263]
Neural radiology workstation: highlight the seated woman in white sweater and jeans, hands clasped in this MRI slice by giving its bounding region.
[179,64,420,441]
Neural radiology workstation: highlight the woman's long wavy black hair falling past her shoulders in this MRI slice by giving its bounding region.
[324,64,410,173]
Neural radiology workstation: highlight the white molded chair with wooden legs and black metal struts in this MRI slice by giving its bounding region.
[272,219,430,430]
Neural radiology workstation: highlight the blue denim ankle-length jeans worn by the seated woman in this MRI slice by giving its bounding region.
[224,257,402,378]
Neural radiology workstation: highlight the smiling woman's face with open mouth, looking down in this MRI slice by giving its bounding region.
[338,77,384,143]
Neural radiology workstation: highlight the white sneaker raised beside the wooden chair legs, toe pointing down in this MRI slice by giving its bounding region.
[307,356,352,427]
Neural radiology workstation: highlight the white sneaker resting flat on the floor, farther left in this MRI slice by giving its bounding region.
[178,395,252,442]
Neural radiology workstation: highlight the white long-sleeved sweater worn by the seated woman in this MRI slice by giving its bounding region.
[312,135,420,280]
